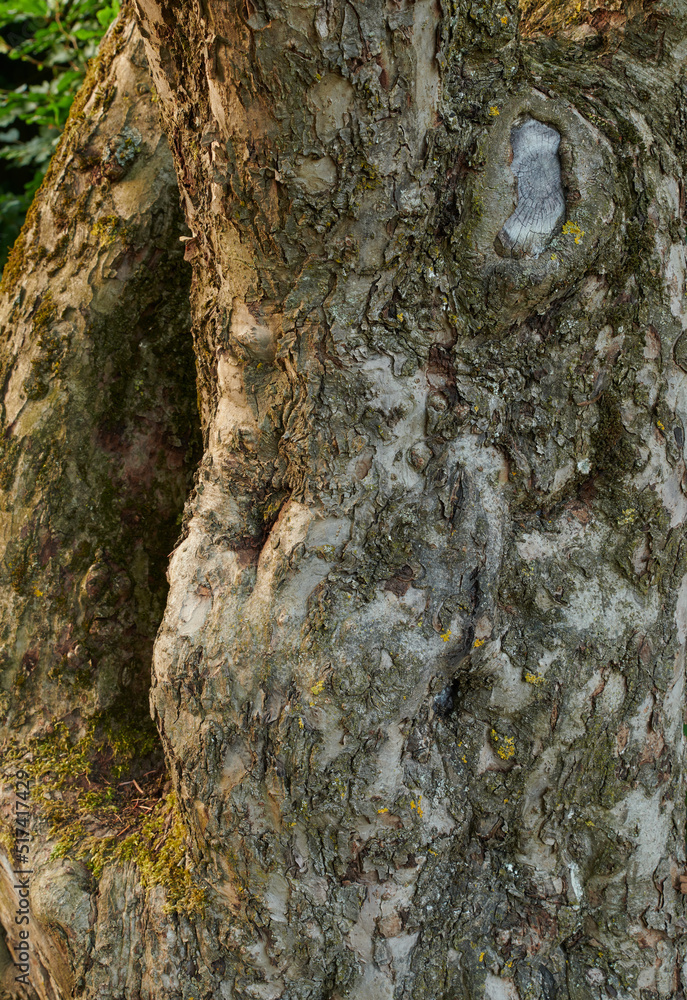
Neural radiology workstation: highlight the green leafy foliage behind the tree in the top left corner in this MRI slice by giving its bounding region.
[0,0,120,269]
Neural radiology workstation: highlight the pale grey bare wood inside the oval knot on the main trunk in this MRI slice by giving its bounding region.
[497,118,565,257]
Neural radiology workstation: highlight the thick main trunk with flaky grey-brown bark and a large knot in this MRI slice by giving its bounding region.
[3,0,687,1000]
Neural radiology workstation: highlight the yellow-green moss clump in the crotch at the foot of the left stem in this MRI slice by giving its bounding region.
[3,701,205,913]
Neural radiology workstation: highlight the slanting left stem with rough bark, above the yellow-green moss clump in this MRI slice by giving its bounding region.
[0,11,197,732]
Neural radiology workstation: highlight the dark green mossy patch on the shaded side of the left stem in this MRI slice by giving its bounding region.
[0,204,200,672]
